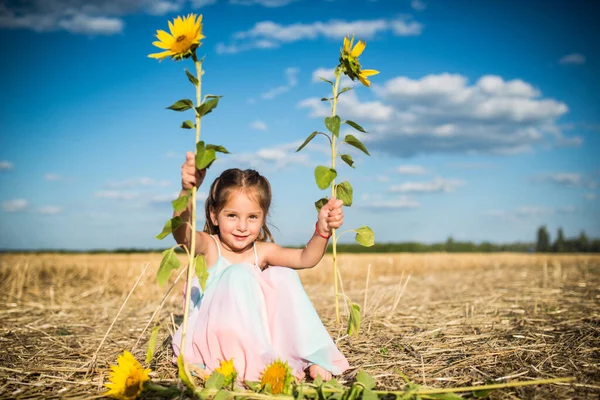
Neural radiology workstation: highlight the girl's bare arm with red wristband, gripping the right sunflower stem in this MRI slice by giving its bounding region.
[261,197,344,269]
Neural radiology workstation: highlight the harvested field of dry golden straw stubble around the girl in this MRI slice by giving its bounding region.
[0,254,600,399]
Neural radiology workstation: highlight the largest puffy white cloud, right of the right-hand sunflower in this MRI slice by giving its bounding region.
[326,73,568,157]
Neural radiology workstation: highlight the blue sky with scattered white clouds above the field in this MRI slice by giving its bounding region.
[0,0,600,250]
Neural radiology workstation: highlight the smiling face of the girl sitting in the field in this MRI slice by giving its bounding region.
[210,190,265,253]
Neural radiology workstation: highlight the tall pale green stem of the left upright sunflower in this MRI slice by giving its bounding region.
[179,53,202,362]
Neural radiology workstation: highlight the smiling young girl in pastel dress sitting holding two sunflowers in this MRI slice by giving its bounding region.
[173,152,349,381]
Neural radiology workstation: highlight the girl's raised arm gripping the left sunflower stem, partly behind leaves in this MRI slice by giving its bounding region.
[173,151,209,254]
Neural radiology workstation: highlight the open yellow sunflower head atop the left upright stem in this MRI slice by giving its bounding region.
[148,14,204,61]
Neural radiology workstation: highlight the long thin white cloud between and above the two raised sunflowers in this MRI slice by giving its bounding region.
[216,16,423,54]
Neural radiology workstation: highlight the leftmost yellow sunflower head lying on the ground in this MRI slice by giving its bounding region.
[104,350,150,400]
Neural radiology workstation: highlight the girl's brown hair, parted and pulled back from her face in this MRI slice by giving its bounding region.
[204,168,275,242]
